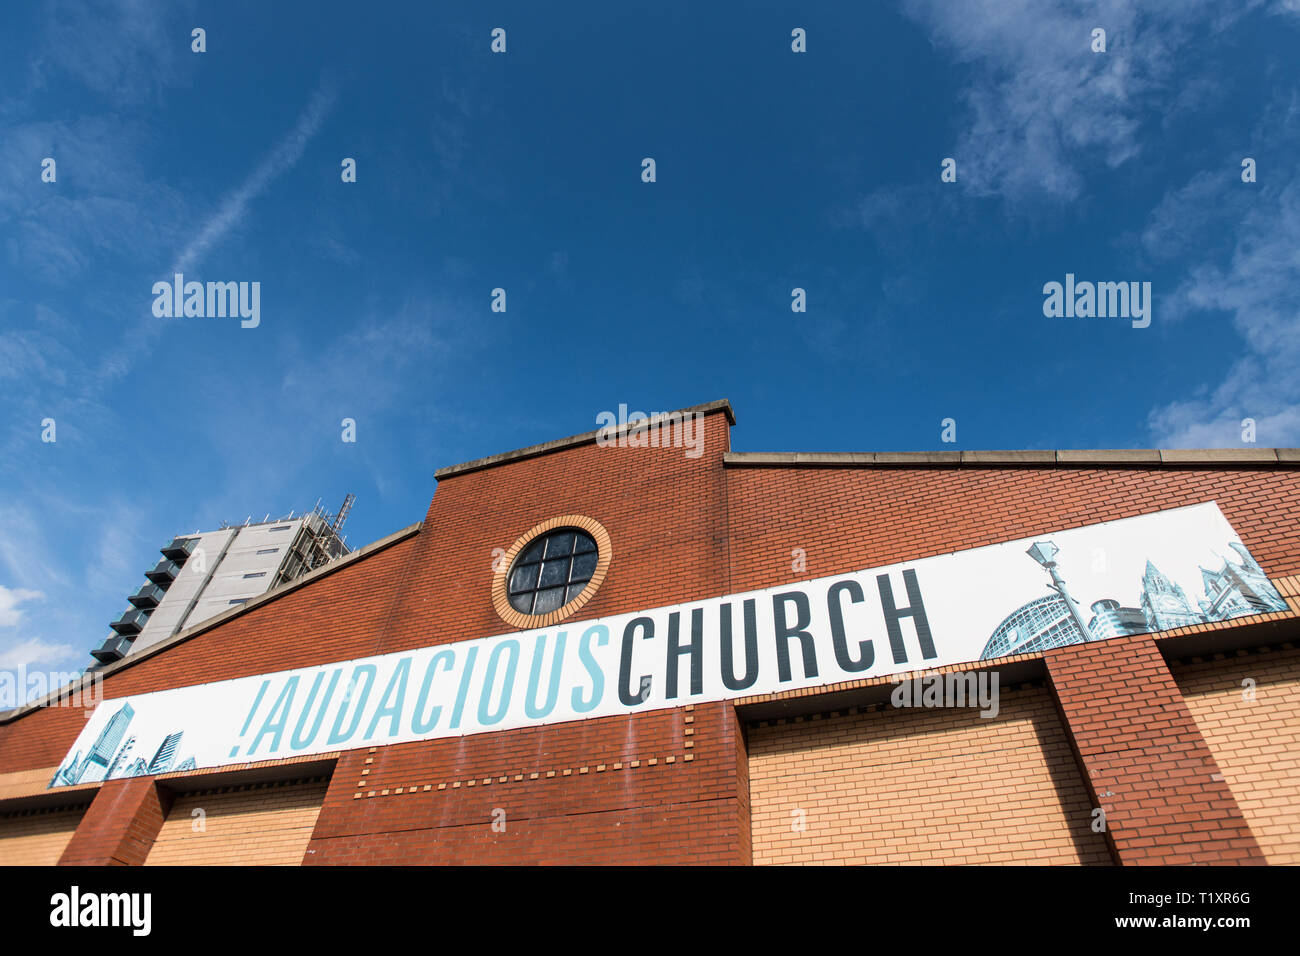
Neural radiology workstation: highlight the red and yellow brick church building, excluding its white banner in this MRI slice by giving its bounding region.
[0,402,1300,865]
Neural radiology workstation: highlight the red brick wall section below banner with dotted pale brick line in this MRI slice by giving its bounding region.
[306,704,749,864]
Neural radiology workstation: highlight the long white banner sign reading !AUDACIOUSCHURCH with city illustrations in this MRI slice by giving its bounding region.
[51,502,1286,787]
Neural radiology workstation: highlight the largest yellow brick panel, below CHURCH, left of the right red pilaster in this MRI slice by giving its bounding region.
[749,687,1110,865]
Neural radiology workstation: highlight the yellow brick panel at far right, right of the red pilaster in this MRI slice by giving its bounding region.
[1170,648,1300,866]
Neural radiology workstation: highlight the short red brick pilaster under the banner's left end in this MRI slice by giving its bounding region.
[59,777,172,866]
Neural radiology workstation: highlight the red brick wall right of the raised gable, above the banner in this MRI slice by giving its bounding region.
[727,467,1300,591]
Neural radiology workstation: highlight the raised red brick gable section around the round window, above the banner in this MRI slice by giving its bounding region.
[384,403,729,653]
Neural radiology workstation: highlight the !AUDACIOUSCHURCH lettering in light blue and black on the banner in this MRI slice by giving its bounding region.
[230,571,936,760]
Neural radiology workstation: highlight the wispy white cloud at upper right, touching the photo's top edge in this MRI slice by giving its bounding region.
[904,0,1261,202]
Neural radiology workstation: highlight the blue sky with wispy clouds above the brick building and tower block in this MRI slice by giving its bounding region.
[0,0,1300,691]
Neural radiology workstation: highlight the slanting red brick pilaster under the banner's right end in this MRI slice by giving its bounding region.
[1045,635,1264,865]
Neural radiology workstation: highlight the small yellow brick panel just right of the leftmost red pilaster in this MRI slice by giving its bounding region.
[144,779,329,866]
